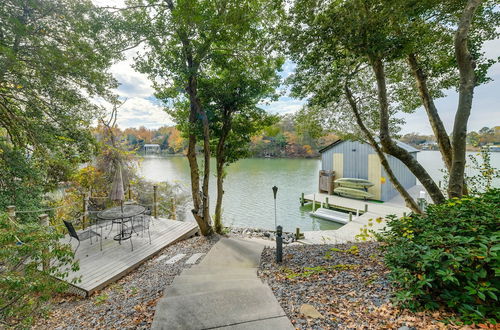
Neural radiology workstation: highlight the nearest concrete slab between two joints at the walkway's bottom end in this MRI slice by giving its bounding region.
[151,286,285,330]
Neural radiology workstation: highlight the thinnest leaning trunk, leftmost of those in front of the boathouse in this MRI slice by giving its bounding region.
[344,83,422,213]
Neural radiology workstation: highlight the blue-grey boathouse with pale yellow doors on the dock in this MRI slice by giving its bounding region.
[319,140,419,201]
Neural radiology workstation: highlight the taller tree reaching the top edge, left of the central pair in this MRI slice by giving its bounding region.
[129,0,281,235]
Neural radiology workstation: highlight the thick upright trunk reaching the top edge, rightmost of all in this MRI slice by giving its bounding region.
[448,0,482,197]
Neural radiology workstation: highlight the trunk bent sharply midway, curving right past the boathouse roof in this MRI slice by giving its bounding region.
[372,58,445,204]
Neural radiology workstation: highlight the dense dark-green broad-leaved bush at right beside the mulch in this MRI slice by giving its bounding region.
[377,189,500,323]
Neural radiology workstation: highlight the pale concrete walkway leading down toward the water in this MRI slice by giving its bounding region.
[152,238,294,330]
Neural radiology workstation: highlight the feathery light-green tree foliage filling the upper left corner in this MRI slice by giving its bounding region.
[0,0,124,211]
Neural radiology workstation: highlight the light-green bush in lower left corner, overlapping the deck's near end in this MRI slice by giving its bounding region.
[0,213,78,328]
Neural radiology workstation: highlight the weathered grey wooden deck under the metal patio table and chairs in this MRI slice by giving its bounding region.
[58,218,198,296]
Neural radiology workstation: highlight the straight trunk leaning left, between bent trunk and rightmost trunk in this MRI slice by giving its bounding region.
[408,54,452,172]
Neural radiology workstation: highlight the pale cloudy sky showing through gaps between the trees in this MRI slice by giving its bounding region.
[107,29,500,134]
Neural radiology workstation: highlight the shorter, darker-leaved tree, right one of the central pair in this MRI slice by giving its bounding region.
[200,60,282,233]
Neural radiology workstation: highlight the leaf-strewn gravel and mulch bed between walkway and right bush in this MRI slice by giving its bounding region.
[259,242,468,330]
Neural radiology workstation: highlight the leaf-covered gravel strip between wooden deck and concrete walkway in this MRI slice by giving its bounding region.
[33,235,218,329]
